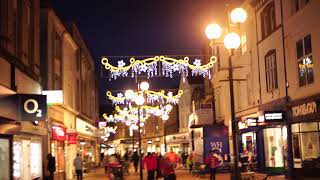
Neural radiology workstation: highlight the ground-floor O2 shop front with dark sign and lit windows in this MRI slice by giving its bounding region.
[0,94,47,180]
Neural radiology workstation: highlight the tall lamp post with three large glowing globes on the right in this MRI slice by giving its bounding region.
[205,8,247,180]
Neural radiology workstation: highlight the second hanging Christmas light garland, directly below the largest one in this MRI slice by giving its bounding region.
[106,90,183,105]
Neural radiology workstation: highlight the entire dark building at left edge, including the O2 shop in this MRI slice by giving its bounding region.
[0,0,47,179]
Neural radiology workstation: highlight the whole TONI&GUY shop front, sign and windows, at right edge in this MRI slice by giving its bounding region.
[288,95,320,178]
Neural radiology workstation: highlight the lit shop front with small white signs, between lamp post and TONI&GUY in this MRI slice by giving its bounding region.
[238,111,287,174]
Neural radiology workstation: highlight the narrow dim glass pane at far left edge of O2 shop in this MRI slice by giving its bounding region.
[0,139,10,179]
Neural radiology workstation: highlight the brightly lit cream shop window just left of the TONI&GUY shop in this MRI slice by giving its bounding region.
[263,127,287,167]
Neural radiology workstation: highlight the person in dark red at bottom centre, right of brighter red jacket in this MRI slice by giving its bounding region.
[160,154,176,180]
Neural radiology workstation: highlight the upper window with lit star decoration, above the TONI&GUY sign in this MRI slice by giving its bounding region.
[296,35,314,87]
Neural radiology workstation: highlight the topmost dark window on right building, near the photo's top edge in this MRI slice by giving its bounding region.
[260,1,276,38]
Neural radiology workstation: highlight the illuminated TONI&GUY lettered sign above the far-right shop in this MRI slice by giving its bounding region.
[291,101,317,117]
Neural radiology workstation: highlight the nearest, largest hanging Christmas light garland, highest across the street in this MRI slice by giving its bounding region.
[101,56,217,80]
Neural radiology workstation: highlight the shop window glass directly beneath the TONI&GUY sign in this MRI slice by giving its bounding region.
[292,122,320,168]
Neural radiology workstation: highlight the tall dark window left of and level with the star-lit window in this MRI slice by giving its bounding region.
[265,49,278,92]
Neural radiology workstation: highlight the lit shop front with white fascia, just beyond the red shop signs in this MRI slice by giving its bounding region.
[76,117,100,172]
